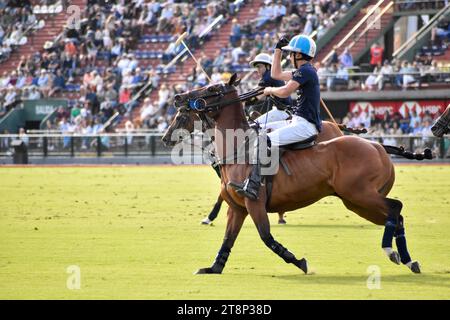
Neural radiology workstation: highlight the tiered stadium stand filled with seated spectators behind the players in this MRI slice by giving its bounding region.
[0,0,450,150]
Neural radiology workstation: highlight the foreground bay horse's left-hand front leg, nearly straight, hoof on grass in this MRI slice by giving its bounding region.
[196,208,247,274]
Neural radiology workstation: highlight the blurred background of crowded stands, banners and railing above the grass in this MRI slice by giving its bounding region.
[0,0,450,164]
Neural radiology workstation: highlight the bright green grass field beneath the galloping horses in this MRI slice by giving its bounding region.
[0,165,450,299]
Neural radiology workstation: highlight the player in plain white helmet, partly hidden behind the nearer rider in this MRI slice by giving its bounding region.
[249,53,292,128]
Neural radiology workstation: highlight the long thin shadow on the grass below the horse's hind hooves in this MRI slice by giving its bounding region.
[264,273,450,289]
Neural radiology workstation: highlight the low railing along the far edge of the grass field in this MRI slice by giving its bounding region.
[0,132,450,159]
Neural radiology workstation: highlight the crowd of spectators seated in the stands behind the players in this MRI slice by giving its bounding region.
[0,0,448,152]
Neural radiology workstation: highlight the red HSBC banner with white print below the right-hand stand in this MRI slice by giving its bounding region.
[349,100,450,119]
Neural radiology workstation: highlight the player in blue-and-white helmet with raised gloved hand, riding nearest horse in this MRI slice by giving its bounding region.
[229,35,322,200]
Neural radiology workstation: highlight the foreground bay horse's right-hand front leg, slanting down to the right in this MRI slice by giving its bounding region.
[245,199,308,274]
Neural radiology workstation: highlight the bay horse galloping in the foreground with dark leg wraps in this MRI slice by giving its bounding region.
[164,75,421,274]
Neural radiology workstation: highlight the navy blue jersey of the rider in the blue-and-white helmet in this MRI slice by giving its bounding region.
[292,62,322,132]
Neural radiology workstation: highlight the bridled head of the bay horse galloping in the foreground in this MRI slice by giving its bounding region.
[175,74,240,118]
